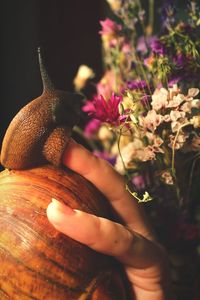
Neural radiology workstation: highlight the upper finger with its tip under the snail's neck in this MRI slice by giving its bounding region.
[63,140,152,237]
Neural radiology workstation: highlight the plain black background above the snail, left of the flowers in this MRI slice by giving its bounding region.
[0,0,106,143]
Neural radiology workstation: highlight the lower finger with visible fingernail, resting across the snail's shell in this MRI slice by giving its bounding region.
[47,199,158,268]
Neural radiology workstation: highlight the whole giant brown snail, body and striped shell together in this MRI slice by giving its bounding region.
[0,48,131,300]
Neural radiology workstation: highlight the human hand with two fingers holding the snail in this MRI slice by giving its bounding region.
[47,141,172,300]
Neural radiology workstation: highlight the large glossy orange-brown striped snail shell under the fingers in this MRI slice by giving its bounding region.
[0,166,131,300]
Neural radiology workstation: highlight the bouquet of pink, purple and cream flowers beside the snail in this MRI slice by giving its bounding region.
[74,0,200,300]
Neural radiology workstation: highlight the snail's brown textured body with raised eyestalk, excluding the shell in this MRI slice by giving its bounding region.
[1,49,83,169]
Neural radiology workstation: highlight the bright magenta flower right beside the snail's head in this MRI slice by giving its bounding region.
[83,93,122,125]
